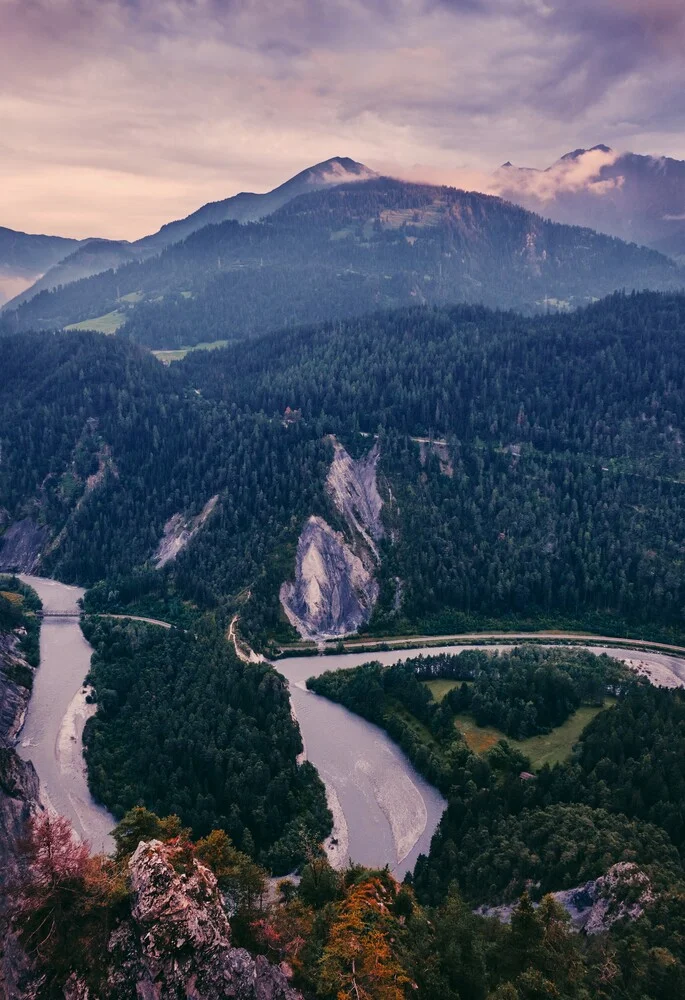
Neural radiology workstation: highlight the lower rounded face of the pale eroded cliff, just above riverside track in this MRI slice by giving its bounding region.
[280,517,378,640]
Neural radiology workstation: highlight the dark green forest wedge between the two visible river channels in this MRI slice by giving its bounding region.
[83,618,331,873]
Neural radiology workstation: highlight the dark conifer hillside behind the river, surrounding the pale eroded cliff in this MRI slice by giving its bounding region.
[0,294,685,643]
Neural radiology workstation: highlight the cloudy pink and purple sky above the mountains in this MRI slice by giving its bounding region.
[0,0,685,239]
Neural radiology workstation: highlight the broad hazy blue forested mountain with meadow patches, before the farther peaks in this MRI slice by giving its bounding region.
[5,178,685,347]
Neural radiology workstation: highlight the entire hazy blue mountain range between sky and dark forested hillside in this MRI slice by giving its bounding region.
[0,145,685,348]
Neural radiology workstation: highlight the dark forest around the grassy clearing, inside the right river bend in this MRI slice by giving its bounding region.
[307,647,685,927]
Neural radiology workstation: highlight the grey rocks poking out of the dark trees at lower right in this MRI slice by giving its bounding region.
[476,861,655,934]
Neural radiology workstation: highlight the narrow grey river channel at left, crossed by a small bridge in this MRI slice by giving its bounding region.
[17,575,116,852]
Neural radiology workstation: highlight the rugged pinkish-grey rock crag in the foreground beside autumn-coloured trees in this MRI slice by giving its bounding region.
[101,840,302,1000]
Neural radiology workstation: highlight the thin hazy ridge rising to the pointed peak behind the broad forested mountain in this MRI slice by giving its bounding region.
[0,156,378,308]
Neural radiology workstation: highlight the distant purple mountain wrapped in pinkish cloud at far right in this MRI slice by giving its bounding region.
[496,145,685,260]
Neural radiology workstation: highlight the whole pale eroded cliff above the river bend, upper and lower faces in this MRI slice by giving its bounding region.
[280,438,384,642]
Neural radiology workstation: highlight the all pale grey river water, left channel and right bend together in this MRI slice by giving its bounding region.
[18,576,685,877]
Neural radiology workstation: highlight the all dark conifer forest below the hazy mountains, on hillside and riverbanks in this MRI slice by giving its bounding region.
[0,293,685,1000]
